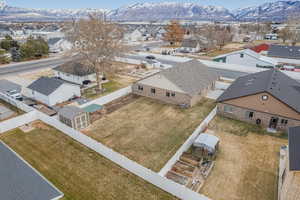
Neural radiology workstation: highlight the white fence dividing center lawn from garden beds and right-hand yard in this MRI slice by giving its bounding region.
[159,107,217,176]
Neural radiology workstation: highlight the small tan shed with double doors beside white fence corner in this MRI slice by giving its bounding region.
[58,106,91,130]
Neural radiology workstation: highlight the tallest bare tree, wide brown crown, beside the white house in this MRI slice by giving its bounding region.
[66,13,125,92]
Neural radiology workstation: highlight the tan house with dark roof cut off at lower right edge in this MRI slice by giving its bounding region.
[278,126,300,200]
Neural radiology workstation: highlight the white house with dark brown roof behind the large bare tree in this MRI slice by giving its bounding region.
[53,61,97,85]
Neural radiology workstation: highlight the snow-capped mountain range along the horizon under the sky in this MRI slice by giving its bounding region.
[0,0,300,21]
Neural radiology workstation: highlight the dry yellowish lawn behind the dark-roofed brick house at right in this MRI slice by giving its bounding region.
[200,117,287,200]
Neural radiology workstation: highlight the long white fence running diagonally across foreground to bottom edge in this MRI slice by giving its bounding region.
[37,112,209,200]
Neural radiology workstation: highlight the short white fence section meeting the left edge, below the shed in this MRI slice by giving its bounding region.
[0,111,38,134]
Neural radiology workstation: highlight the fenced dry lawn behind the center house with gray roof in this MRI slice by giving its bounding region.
[84,97,215,171]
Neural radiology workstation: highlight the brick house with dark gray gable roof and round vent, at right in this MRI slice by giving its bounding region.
[217,69,300,131]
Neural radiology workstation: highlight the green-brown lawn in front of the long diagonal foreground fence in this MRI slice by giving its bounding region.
[0,122,176,200]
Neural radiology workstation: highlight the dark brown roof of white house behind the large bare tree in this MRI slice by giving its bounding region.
[53,61,95,76]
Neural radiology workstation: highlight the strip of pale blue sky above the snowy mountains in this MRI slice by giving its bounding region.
[6,0,274,9]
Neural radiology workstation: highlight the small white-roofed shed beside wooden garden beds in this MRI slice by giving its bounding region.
[193,133,220,158]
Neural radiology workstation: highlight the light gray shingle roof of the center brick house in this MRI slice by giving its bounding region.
[161,60,219,96]
